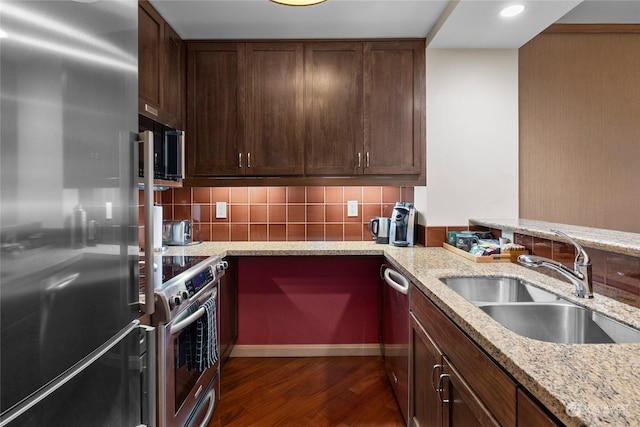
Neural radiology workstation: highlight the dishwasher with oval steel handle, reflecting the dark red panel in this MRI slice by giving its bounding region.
[380,264,410,422]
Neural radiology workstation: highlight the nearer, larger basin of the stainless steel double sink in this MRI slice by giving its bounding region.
[480,303,640,344]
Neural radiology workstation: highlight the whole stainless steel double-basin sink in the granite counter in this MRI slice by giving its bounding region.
[440,277,640,344]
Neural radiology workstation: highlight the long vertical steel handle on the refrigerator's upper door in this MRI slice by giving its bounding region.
[138,130,156,315]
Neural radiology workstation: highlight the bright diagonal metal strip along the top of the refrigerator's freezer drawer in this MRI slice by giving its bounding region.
[0,319,140,427]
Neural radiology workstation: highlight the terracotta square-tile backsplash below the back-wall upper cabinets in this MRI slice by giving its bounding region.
[140,186,414,241]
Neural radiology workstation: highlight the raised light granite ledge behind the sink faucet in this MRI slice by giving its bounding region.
[469,218,640,257]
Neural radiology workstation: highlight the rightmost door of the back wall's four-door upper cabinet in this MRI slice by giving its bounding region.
[364,41,425,175]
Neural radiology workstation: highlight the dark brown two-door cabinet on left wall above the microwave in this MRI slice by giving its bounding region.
[138,0,184,128]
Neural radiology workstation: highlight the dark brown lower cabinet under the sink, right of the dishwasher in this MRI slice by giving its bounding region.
[409,286,562,427]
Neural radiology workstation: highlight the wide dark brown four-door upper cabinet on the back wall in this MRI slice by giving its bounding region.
[185,40,425,186]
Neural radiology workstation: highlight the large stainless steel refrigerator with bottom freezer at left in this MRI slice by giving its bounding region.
[0,0,155,427]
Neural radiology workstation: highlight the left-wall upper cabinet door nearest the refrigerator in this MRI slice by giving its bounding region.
[138,1,164,113]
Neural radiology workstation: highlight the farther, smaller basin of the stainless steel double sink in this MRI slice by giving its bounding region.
[440,277,564,305]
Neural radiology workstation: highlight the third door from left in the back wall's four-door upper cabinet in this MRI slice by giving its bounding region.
[304,42,364,175]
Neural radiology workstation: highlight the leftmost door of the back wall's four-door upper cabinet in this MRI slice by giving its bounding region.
[186,43,246,178]
